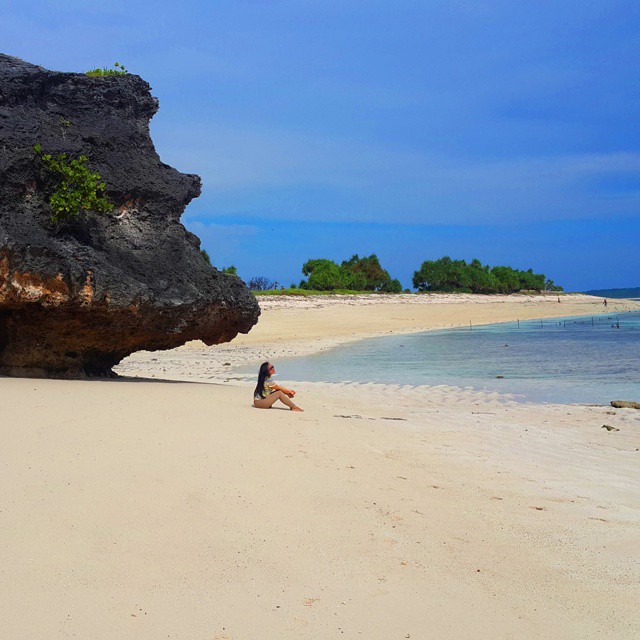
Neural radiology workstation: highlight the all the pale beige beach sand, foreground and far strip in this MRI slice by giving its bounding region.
[0,296,640,640]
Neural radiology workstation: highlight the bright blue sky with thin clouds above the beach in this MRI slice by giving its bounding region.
[0,0,640,291]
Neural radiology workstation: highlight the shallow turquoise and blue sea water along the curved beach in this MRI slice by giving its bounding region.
[264,312,640,404]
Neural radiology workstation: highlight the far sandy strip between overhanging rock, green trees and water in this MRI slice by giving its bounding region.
[116,294,640,390]
